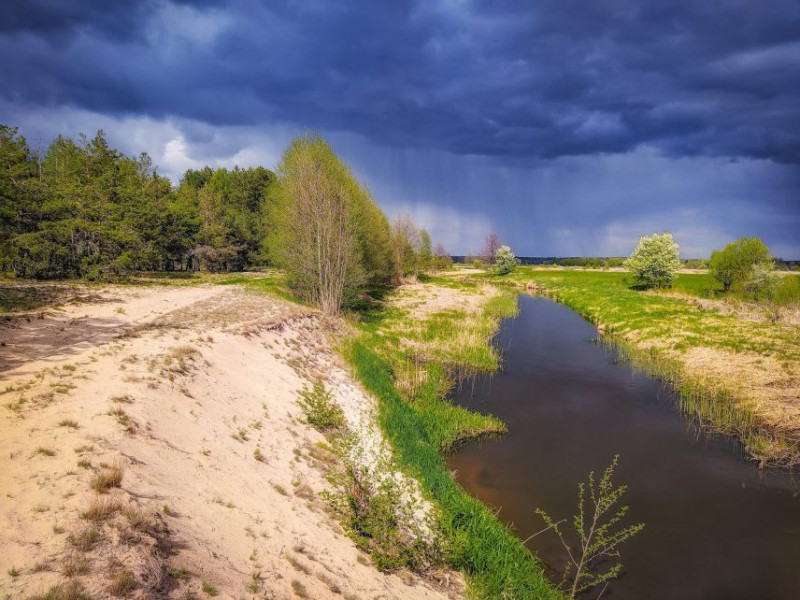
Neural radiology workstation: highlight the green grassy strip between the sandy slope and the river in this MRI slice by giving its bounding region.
[343,278,561,599]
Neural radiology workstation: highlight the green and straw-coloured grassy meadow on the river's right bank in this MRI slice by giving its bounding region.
[480,267,800,466]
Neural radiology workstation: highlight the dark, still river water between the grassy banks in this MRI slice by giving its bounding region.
[447,295,800,600]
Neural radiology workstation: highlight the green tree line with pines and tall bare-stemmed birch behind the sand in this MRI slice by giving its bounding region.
[0,125,452,312]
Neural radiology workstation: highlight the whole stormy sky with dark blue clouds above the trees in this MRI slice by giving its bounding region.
[0,0,800,259]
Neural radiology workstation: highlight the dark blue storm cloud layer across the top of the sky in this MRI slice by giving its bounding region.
[0,0,800,163]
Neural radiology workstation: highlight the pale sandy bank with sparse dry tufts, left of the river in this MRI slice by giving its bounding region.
[0,286,463,599]
